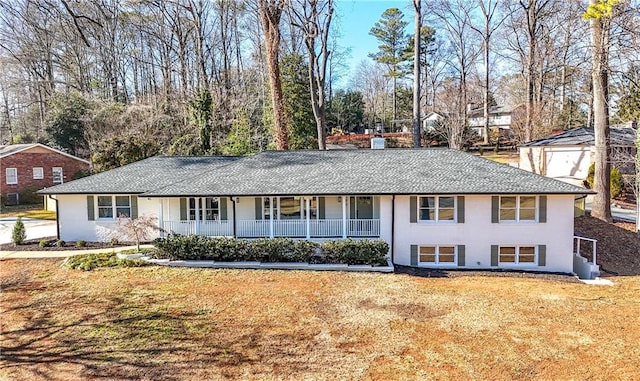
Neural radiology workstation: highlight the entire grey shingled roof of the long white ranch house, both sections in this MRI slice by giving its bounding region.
[41,148,592,197]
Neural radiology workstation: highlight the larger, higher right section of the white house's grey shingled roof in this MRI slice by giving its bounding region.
[145,149,592,196]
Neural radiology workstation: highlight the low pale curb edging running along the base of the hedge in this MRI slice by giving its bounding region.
[140,257,393,273]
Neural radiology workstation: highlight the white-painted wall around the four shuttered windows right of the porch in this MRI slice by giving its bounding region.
[393,195,574,272]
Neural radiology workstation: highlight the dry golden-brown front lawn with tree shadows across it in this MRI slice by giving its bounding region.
[0,260,640,380]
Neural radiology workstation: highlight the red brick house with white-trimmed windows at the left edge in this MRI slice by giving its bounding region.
[0,143,90,207]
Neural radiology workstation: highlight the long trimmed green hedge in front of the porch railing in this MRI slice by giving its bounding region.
[152,235,389,266]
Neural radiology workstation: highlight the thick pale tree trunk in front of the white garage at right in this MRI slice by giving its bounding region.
[590,0,612,221]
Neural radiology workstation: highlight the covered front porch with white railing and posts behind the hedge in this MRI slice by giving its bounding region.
[159,195,381,239]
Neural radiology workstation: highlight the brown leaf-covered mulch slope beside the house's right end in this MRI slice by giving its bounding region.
[574,216,640,276]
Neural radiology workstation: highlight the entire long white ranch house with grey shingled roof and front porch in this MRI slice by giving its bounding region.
[41,149,591,273]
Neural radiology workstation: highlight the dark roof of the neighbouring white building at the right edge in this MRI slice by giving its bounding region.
[522,127,636,147]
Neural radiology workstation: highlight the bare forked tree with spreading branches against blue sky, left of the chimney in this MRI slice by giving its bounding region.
[289,0,333,150]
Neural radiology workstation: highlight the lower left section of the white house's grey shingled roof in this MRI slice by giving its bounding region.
[38,156,237,194]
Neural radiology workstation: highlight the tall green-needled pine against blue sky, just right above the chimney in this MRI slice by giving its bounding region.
[369,8,409,129]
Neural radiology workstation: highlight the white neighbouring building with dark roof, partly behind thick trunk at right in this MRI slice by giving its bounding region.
[518,126,636,185]
